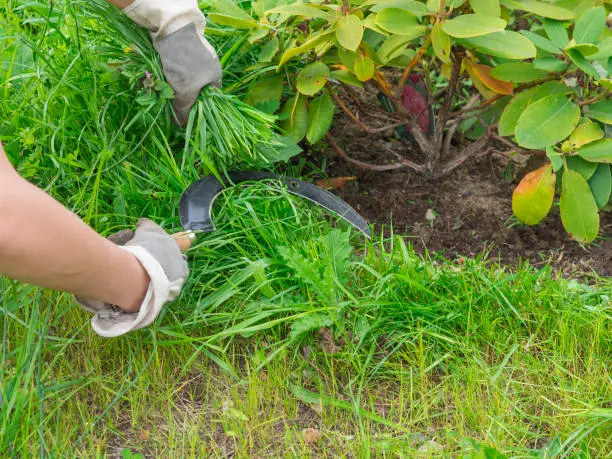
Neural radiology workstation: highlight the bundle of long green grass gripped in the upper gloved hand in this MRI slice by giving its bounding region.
[84,0,292,172]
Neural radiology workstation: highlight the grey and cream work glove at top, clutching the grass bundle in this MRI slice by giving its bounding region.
[123,0,221,126]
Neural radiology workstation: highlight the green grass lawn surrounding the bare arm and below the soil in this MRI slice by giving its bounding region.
[0,0,612,458]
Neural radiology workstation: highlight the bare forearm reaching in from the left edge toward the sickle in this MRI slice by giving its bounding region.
[0,143,149,312]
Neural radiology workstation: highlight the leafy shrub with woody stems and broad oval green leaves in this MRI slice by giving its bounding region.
[203,0,612,242]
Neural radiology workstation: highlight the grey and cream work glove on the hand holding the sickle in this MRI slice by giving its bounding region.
[76,218,189,338]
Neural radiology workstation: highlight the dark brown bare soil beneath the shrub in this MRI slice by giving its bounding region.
[311,88,612,277]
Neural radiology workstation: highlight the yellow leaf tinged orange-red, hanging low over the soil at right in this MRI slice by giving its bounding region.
[512,164,557,225]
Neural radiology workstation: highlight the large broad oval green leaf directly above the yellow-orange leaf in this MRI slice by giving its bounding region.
[515,95,580,149]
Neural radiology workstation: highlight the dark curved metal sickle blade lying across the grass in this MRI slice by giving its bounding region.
[179,172,371,238]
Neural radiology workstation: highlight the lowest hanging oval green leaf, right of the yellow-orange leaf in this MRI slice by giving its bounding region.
[559,169,599,242]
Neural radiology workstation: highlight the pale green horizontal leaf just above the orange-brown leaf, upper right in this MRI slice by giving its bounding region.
[457,30,537,60]
